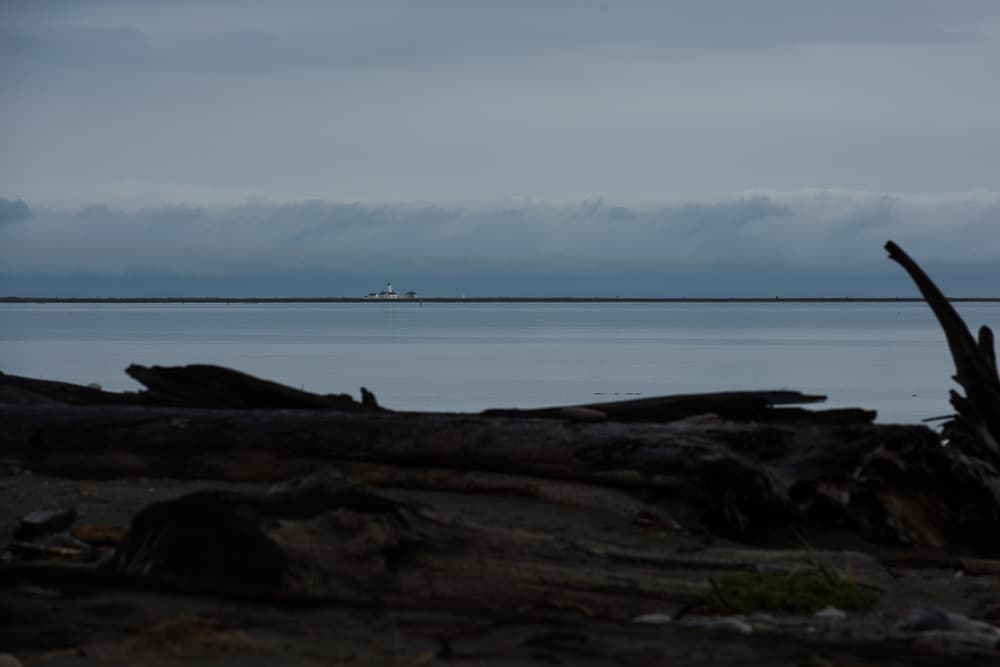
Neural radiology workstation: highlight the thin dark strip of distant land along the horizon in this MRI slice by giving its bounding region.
[0,296,1000,304]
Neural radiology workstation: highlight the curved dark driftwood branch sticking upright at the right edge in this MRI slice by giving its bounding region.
[885,241,1000,461]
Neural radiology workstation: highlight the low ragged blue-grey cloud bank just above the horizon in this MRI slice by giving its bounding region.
[0,192,1000,296]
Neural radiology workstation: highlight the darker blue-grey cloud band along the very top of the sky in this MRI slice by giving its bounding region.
[7,0,1000,72]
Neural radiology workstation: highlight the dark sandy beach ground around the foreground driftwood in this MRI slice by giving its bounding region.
[0,471,1000,667]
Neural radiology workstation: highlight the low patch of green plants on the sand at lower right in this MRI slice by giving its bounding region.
[708,572,876,614]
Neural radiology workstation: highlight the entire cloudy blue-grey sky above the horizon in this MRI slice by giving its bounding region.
[0,0,1000,296]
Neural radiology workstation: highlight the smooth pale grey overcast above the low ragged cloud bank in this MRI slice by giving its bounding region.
[0,0,1000,206]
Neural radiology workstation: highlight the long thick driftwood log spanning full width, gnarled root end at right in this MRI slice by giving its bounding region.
[0,406,1000,555]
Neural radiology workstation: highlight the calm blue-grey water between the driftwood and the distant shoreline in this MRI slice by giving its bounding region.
[0,303,1000,421]
